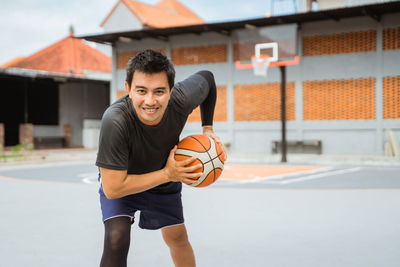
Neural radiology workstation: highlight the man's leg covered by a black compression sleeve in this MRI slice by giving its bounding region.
[100,217,131,267]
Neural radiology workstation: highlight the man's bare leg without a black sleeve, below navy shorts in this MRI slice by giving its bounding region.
[161,224,196,267]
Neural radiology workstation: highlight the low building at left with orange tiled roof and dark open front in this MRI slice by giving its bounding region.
[0,32,111,151]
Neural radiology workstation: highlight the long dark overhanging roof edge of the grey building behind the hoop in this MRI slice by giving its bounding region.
[80,1,400,43]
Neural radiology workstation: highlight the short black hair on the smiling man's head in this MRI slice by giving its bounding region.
[125,49,175,90]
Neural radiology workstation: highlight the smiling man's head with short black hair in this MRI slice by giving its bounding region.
[125,50,175,126]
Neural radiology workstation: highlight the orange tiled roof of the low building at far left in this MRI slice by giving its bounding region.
[1,34,111,76]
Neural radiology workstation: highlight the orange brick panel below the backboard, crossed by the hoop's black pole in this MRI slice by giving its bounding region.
[234,82,295,121]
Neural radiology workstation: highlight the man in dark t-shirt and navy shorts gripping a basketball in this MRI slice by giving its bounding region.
[96,50,219,267]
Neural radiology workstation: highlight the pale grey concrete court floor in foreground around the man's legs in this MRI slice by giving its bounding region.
[0,165,400,267]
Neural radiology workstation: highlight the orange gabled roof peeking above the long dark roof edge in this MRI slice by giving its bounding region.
[100,0,204,28]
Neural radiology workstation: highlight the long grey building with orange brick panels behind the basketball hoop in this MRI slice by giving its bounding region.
[82,1,400,154]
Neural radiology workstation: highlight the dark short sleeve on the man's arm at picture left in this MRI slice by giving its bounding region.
[96,110,129,170]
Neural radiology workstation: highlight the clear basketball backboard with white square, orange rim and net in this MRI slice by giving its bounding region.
[234,24,299,76]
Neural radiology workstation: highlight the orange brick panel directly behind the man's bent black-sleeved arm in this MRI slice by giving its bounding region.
[188,85,228,122]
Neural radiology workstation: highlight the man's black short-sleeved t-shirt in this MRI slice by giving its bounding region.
[96,73,215,192]
